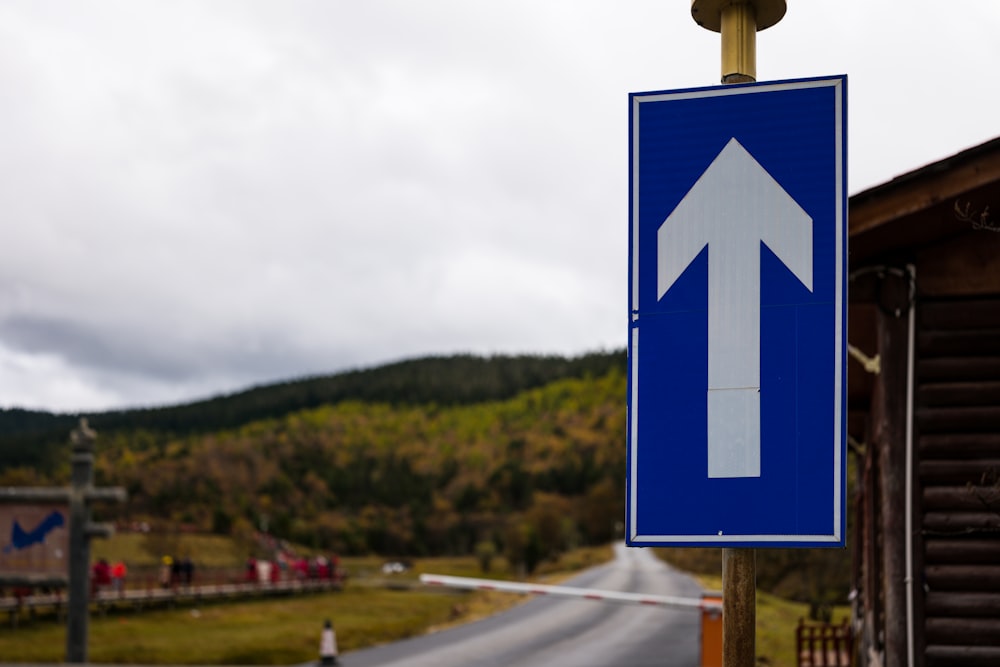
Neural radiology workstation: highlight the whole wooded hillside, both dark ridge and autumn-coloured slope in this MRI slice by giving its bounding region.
[0,352,850,608]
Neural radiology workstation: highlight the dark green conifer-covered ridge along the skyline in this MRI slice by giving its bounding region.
[0,350,626,470]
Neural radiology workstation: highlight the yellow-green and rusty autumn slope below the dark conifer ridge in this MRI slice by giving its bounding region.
[98,371,625,570]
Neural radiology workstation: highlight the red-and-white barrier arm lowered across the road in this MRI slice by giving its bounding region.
[420,574,722,614]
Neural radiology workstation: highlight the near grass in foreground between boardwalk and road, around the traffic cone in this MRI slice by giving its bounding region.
[0,586,457,664]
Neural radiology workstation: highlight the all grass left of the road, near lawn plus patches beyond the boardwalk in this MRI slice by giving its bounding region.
[0,536,612,665]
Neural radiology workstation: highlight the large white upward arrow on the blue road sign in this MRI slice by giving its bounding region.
[656,138,813,477]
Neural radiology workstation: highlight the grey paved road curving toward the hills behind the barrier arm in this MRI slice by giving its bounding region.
[340,544,701,667]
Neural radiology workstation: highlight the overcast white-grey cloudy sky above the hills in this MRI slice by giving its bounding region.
[0,0,1000,412]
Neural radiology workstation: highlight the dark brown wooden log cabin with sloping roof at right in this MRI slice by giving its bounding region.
[848,139,1000,667]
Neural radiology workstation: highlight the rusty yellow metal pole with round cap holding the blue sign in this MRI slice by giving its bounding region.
[691,0,785,667]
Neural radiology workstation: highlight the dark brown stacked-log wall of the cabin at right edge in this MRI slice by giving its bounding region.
[912,297,1000,667]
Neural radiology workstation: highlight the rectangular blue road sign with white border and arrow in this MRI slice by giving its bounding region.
[626,76,847,547]
